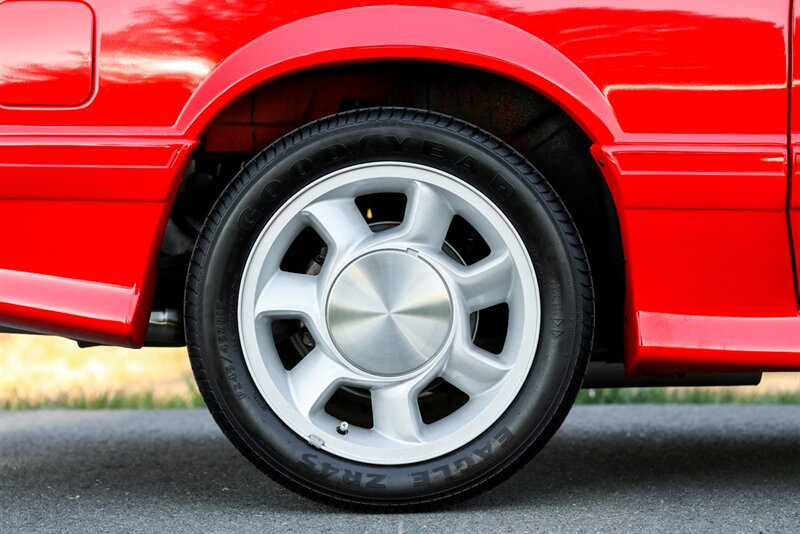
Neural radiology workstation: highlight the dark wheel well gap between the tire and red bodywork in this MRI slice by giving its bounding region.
[154,62,625,361]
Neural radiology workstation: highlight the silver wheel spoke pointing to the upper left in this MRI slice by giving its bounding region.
[303,198,372,257]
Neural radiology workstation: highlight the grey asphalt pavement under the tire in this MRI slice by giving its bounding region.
[0,405,800,534]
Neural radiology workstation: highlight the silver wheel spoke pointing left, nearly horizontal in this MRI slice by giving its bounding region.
[255,271,320,322]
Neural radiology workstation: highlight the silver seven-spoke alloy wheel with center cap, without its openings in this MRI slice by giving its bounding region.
[238,161,541,465]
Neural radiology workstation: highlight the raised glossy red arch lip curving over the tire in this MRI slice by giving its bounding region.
[175,6,621,143]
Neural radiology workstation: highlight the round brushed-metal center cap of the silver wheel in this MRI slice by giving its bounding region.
[327,250,452,376]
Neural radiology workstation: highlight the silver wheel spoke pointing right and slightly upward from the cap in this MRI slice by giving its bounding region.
[447,250,514,312]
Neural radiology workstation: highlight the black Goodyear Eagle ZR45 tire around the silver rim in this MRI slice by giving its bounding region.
[185,108,594,511]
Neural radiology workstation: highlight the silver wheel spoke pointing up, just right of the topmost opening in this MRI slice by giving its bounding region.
[396,182,454,249]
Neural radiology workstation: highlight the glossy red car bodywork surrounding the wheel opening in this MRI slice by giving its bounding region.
[0,0,800,374]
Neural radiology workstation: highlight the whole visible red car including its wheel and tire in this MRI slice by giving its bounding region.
[0,0,800,510]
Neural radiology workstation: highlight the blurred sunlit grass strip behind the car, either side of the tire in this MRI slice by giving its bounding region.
[0,334,800,410]
